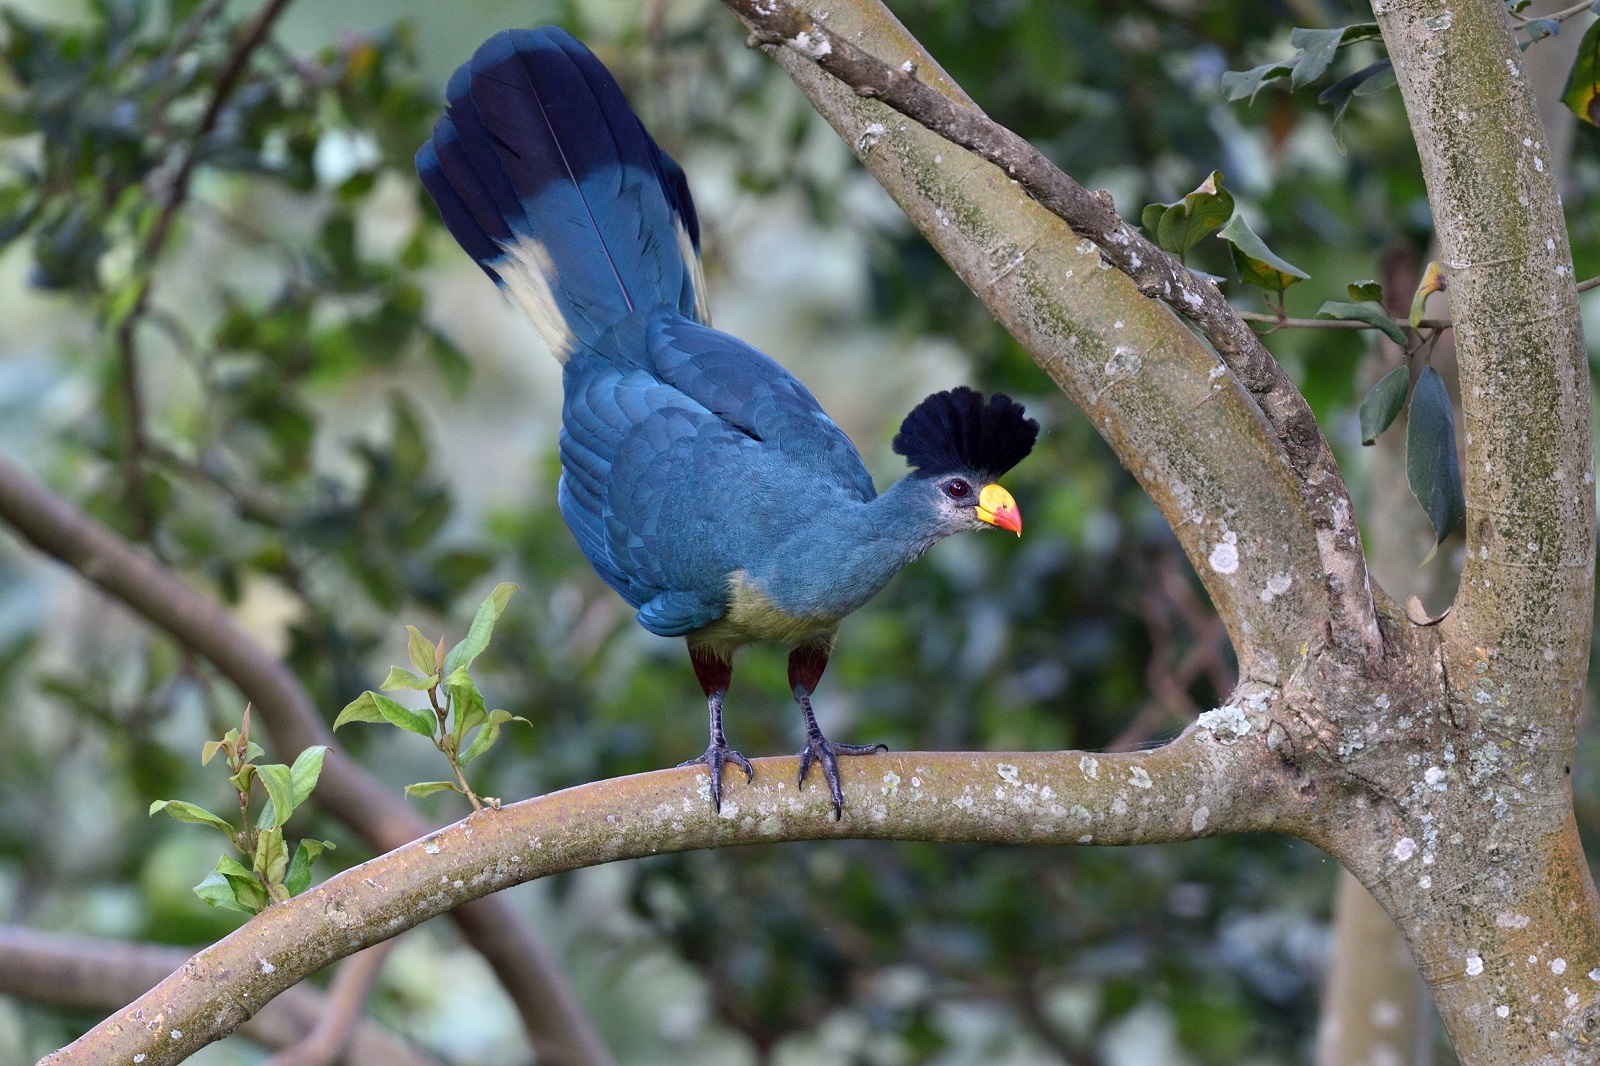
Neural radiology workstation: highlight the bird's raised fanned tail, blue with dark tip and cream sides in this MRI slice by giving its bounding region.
[416,26,706,362]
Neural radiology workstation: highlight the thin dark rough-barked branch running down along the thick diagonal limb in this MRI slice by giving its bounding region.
[723,0,1382,658]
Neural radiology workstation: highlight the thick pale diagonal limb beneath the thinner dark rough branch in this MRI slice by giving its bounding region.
[726,0,1326,680]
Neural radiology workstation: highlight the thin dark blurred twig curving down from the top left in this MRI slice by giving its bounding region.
[117,0,300,541]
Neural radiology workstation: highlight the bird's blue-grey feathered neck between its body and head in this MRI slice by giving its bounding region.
[763,479,949,618]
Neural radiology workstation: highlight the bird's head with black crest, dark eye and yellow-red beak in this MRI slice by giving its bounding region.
[894,386,1038,536]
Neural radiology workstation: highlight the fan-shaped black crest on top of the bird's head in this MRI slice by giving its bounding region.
[894,386,1038,480]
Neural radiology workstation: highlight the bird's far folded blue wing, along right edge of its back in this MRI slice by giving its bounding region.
[646,309,877,501]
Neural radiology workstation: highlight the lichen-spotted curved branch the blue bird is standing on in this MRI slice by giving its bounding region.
[40,726,1298,1066]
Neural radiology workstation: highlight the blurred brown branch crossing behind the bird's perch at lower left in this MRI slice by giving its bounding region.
[0,458,611,1066]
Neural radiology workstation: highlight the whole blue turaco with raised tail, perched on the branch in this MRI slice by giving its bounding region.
[416,27,1038,818]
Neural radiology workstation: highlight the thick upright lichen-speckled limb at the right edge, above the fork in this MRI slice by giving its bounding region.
[1376,0,1595,672]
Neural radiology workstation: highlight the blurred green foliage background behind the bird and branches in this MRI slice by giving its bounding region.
[0,0,1600,1064]
